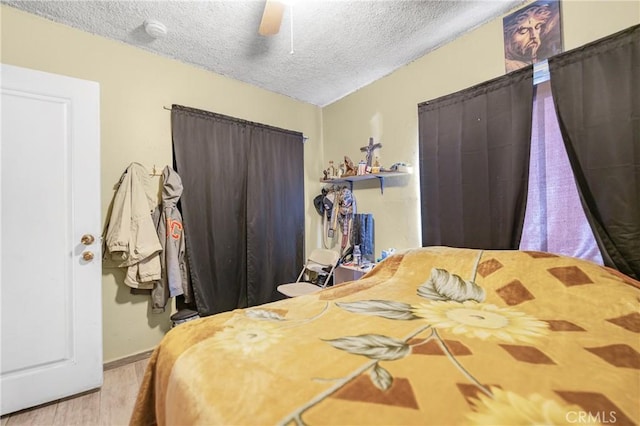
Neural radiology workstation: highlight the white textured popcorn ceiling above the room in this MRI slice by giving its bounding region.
[0,0,526,106]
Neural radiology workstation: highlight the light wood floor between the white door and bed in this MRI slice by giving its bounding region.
[0,358,148,426]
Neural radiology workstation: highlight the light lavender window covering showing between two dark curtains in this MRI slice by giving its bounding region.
[520,81,603,264]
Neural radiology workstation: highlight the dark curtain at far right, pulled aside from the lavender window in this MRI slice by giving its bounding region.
[549,25,640,279]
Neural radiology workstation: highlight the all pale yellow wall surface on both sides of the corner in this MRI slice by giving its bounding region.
[0,0,640,361]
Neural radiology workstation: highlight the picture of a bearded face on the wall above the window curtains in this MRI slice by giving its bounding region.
[502,0,562,72]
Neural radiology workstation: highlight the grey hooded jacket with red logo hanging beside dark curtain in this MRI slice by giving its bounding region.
[151,166,192,313]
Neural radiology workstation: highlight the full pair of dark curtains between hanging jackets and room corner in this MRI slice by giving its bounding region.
[171,105,304,316]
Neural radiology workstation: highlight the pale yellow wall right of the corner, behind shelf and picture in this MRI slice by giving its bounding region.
[322,0,640,255]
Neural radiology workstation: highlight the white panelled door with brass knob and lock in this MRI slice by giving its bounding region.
[0,64,102,414]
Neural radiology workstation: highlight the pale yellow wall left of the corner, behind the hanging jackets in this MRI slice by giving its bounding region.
[0,5,322,361]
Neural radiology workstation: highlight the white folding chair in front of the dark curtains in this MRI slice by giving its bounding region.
[278,249,340,297]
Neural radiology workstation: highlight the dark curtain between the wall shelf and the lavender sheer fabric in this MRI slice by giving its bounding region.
[418,66,533,249]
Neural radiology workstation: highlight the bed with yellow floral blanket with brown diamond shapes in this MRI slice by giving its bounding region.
[131,247,640,425]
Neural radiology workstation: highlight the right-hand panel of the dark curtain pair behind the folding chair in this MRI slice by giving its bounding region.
[247,126,304,306]
